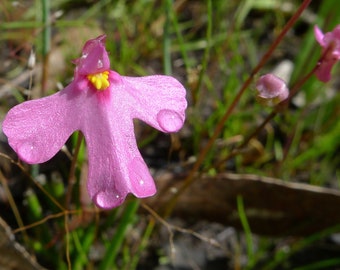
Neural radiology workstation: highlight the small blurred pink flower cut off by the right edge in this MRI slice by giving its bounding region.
[314,25,340,82]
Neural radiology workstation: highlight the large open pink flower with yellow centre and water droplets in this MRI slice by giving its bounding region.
[3,35,187,209]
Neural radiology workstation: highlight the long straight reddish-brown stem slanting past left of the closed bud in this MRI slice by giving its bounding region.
[164,0,311,216]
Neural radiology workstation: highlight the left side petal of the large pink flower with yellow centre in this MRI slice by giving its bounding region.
[2,84,82,164]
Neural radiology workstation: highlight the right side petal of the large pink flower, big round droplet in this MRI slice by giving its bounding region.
[122,75,187,132]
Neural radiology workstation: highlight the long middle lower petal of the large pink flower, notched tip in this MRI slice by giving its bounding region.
[81,83,156,209]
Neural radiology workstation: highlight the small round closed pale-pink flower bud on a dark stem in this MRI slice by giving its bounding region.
[256,74,289,107]
